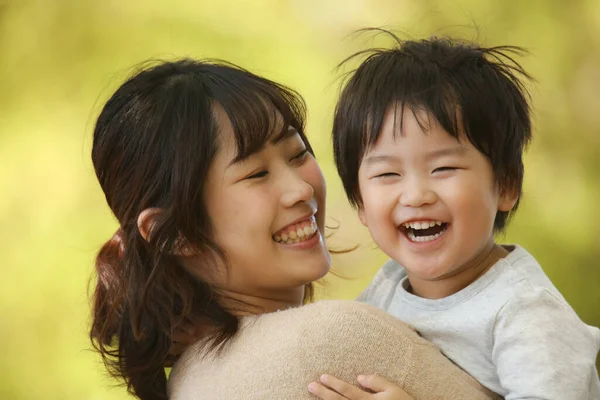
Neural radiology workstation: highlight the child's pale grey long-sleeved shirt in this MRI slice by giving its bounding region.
[358,246,600,400]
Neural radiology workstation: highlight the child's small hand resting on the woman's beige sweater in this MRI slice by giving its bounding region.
[308,375,412,400]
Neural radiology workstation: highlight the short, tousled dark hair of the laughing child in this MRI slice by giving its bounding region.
[333,29,531,232]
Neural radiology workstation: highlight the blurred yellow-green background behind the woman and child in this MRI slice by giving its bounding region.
[0,0,600,400]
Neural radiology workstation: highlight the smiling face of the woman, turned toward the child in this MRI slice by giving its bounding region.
[199,108,331,297]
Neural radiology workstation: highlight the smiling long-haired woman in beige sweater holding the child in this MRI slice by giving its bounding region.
[91,60,502,399]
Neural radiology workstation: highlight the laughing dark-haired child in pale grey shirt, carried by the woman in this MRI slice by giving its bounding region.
[312,35,600,400]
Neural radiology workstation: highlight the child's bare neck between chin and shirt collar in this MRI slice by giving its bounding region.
[408,240,509,299]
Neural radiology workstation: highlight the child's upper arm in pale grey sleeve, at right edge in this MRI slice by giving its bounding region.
[492,288,600,400]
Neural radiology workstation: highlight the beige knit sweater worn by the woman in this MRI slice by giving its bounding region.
[169,300,498,400]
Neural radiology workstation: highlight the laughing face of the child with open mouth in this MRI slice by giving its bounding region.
[359,107,516,296]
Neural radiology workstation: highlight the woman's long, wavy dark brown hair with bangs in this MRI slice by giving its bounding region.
[90,59,312,400]
